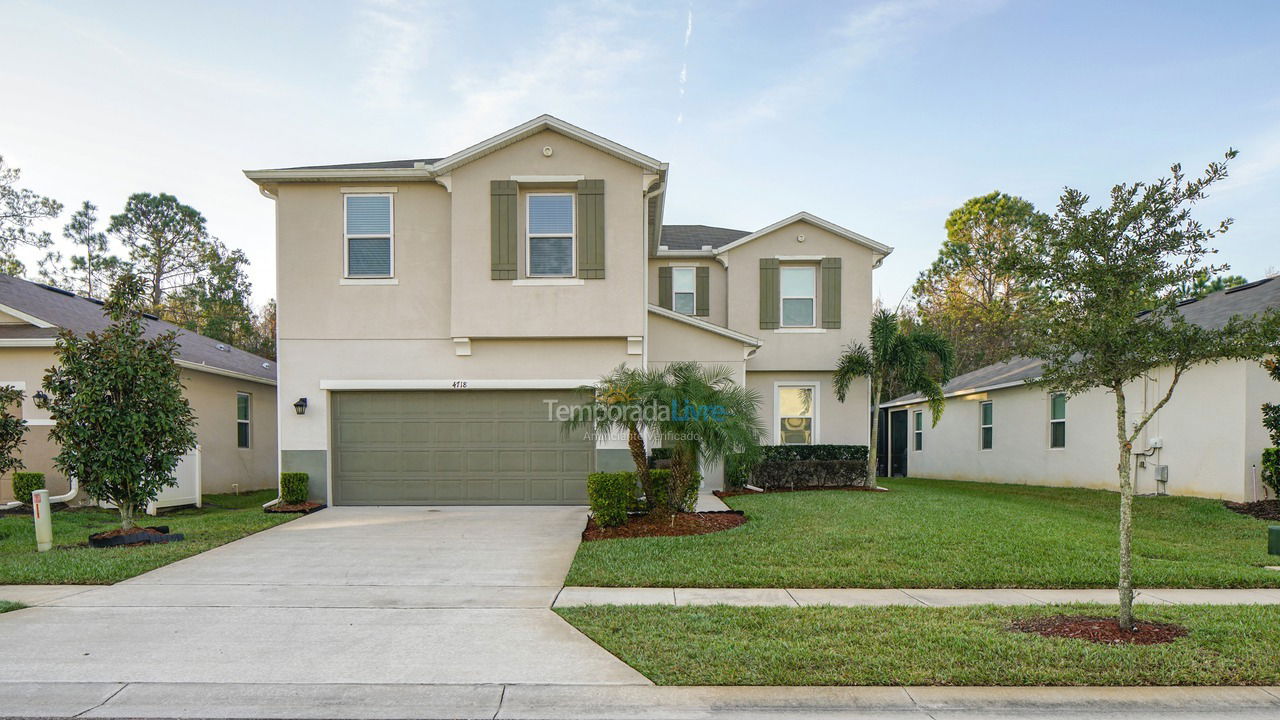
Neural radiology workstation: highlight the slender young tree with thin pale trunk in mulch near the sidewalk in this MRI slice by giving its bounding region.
[1020,150,1280,628]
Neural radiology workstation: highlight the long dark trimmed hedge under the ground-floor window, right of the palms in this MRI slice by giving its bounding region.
[724,445,868,489]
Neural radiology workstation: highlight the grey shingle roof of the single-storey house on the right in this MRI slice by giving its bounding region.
[881,277,1280,407]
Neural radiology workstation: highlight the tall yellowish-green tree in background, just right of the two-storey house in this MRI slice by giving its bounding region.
[911,191,1043,373]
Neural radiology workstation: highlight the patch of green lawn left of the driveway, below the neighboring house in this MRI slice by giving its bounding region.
[0,489,296,584]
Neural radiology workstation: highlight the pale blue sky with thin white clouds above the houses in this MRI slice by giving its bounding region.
[0,0,1280,306]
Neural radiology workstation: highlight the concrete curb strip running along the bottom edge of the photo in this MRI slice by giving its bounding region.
[0,683,1280,720]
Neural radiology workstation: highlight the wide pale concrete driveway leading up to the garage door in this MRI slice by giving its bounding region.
[0,507,648,684]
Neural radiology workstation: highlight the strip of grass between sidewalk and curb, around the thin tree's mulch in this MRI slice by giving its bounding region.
[557,605,1280,685]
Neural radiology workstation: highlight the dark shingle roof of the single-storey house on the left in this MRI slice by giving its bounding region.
[0,275,275,384]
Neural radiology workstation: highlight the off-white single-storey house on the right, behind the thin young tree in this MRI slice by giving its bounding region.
[882,278,1280,502]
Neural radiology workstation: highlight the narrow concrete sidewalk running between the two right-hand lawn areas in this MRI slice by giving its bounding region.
[554,587,1280,607]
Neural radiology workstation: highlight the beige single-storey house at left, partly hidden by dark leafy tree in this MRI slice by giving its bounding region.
[0,275,276,501]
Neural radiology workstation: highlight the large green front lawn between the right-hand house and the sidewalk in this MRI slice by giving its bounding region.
[566,479,1280,588]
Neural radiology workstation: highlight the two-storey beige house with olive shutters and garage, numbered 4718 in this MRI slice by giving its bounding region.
[246,115,891,505]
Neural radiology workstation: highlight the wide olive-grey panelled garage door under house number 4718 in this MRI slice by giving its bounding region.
[332,391,595,505]
